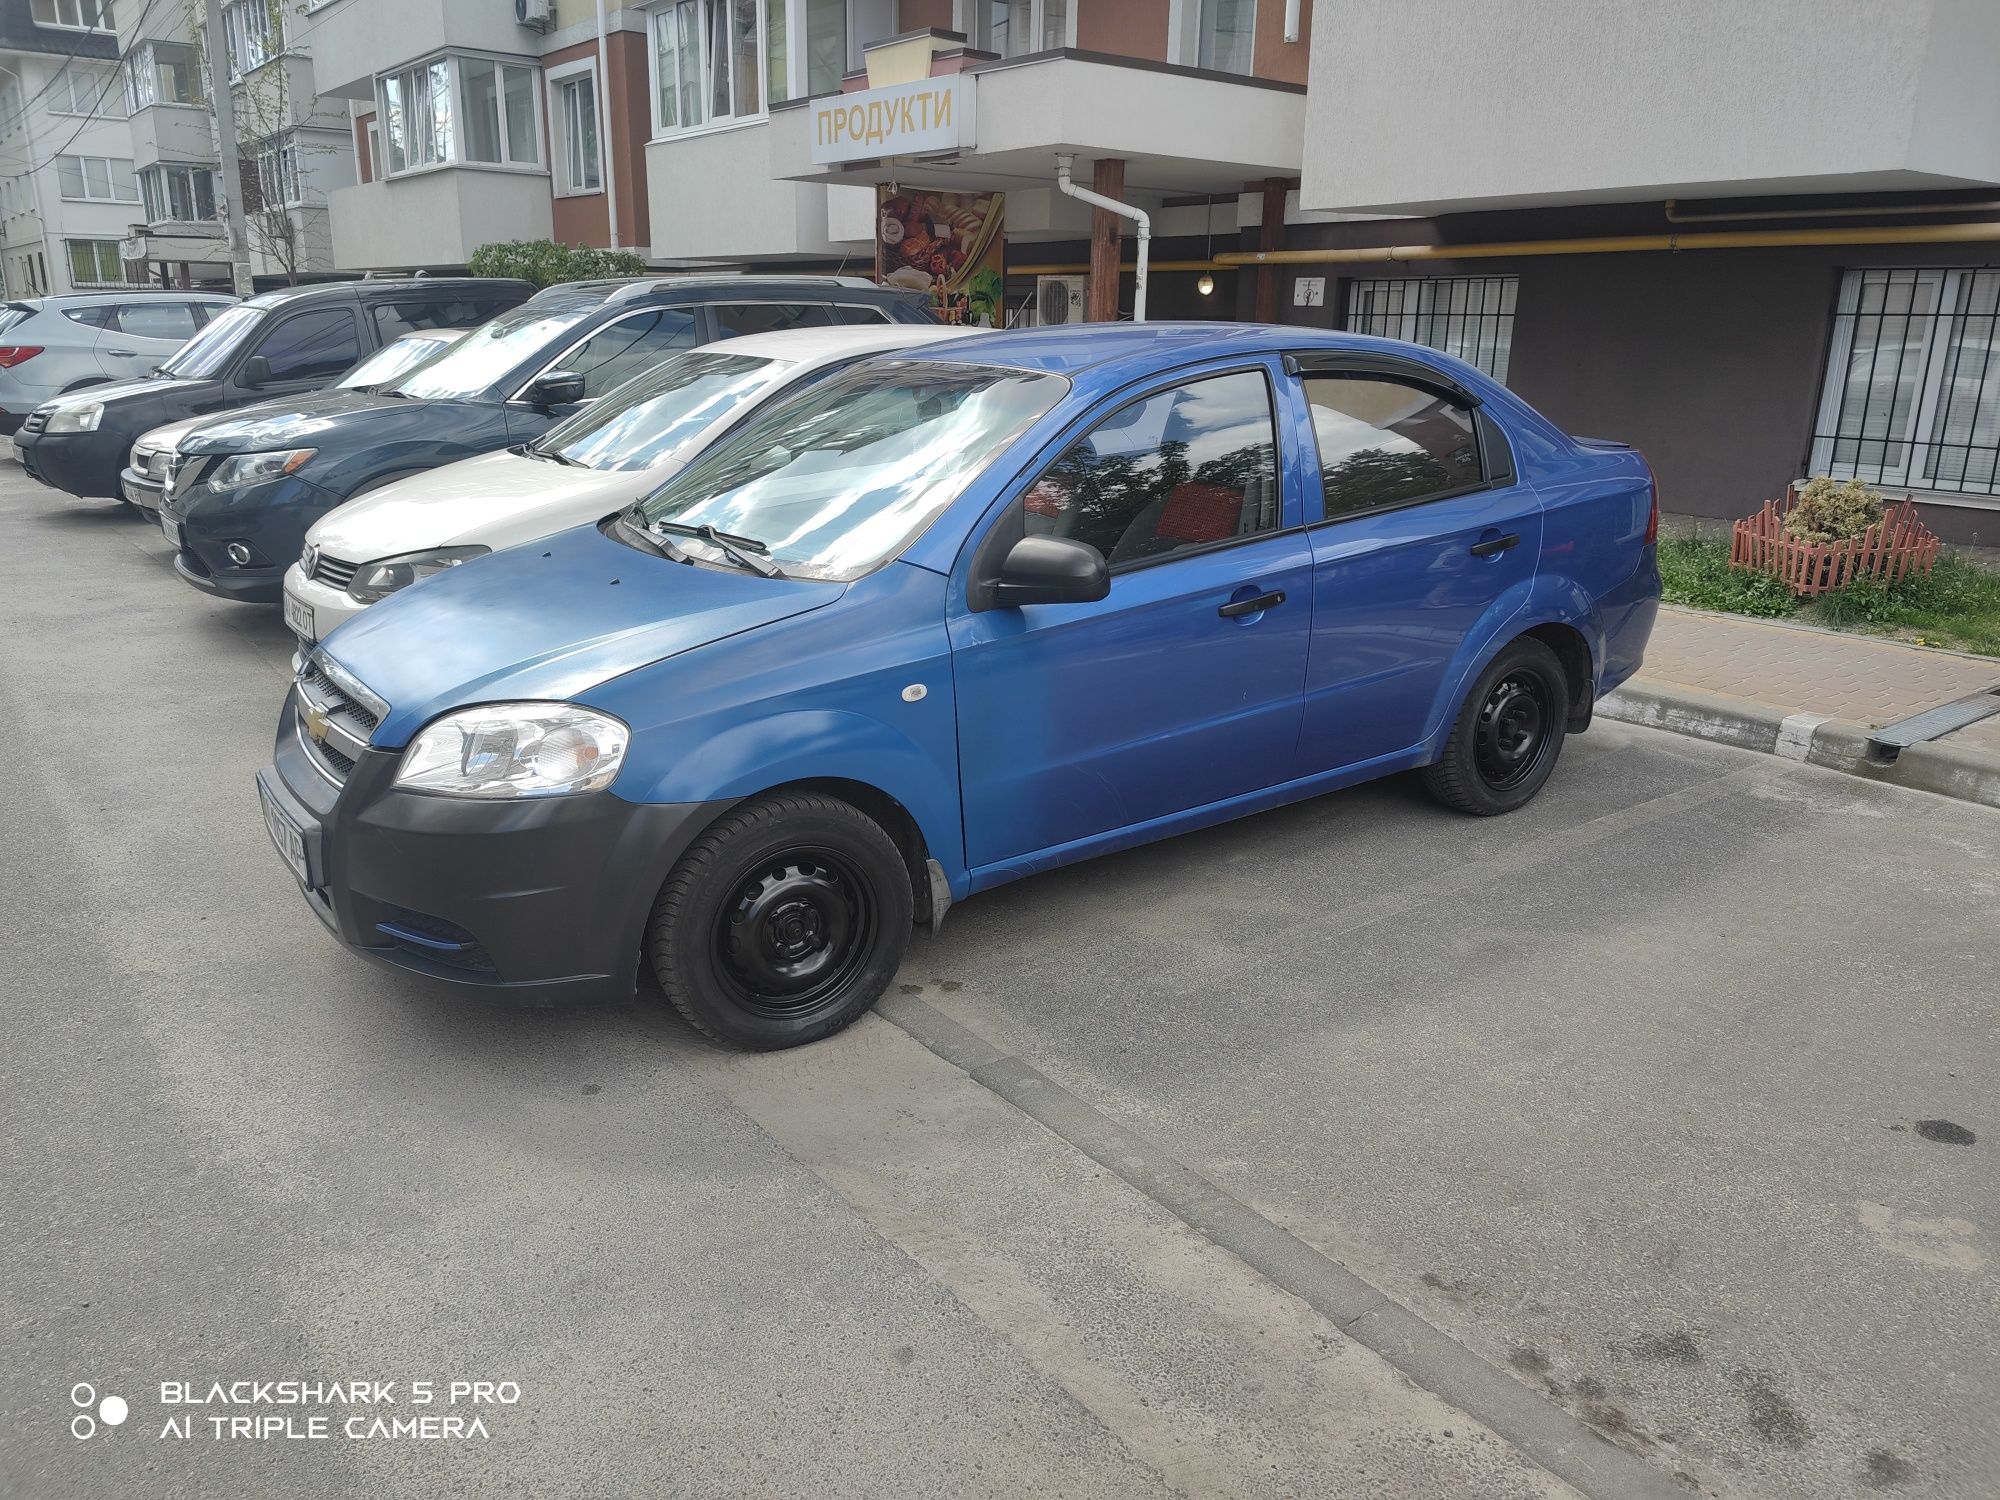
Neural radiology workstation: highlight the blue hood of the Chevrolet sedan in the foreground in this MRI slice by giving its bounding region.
[318,526,846,750]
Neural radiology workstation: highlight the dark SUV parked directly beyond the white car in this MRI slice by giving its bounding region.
[160,276,936,604]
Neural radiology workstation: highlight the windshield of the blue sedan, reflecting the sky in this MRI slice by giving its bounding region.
[636,360,1068,580]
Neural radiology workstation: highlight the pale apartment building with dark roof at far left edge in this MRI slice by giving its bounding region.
[0,0,140,296]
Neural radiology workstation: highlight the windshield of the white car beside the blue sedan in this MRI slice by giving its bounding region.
[534,350,790,470]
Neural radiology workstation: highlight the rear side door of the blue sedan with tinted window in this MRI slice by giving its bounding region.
[1296,358,1542,772]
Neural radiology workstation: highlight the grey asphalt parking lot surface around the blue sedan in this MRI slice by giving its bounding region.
[0,462,2000,1500]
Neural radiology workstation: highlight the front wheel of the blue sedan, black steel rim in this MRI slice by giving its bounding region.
[646,792,914,1052]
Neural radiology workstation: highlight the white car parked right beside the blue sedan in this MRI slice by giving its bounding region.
[284,324,978,644]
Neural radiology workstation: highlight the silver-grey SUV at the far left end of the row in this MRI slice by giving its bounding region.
[0,288,236,436]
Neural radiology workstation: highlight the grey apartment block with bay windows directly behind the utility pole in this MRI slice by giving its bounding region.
[118,0,354,284]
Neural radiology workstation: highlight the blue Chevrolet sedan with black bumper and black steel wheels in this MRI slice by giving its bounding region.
[258,324,1660,1048]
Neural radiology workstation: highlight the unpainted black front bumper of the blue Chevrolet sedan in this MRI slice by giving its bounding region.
[258,694,728,998]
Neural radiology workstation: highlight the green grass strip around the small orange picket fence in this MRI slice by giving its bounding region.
[1660,536,2000,656]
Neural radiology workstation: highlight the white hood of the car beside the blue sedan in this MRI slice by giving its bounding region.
[306,452,660,562]
